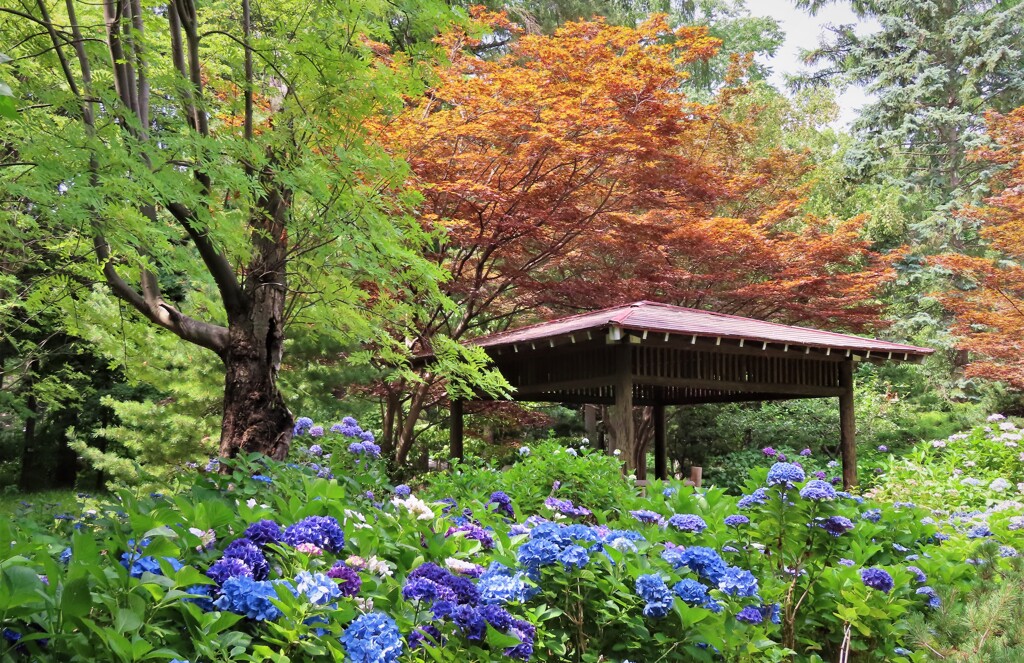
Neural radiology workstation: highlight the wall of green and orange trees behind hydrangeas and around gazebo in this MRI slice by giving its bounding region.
[0,0,1024,490]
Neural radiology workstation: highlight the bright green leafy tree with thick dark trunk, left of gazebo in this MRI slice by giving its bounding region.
[0,0,452,458]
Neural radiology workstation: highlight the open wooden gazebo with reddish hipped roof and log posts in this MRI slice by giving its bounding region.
[451,301,934,488]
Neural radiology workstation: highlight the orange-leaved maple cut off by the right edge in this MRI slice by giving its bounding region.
[936,107,1024,389]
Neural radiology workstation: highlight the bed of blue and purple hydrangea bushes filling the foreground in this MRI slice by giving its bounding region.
[0,419,1024,663]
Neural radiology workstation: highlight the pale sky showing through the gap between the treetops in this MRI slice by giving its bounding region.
[746,0,871,127]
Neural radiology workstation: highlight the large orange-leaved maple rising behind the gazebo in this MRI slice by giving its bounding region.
[372,14,882,464]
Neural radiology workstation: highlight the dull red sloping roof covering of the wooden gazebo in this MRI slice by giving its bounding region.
[470,301,935,357]
